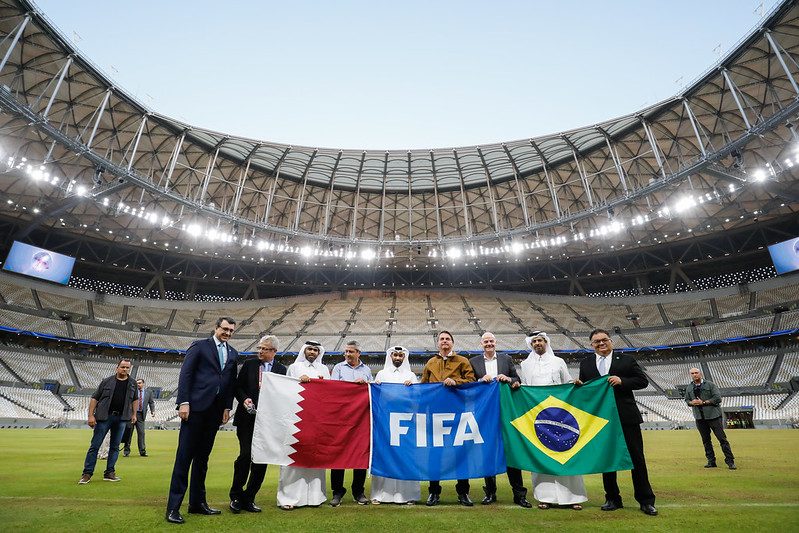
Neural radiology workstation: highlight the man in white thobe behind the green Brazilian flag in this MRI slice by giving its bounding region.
[520,331,588,511]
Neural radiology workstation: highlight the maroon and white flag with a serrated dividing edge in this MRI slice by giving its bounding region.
[252,372,369,468]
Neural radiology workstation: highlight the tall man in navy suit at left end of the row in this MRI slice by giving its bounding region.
[166,317,239,524]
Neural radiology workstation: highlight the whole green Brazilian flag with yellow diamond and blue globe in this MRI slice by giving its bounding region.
[500,379,633,476]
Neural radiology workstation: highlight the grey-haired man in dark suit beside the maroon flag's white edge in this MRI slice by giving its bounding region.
[230,335,286,513]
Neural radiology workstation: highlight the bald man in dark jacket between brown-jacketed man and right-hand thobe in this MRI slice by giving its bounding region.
[469,331,532,508]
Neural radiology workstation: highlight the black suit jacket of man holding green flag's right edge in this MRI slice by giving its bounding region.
[580,352,649,425]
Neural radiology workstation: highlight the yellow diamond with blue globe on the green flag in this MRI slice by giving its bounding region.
[511,396,608,465]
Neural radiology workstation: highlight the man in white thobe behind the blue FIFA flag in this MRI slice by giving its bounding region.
[372,346,422,505]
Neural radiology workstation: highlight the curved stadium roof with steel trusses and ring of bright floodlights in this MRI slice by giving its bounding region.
[0,0,799,298]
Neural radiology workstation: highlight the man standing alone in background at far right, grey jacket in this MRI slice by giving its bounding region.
[685,368,738,470]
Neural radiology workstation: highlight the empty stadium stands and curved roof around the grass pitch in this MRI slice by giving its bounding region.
[0,0,799,436]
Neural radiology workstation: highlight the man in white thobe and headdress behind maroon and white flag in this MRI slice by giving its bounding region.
[277,341,330,511]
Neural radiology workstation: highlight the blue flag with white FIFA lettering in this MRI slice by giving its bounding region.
[369,381,505,481]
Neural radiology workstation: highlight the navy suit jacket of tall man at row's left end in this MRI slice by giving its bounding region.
[177,337,239,412]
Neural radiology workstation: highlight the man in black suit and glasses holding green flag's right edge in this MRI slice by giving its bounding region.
[575,329,658,516]
